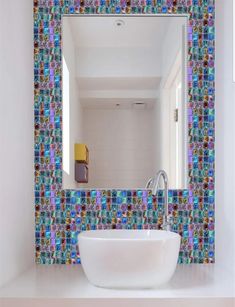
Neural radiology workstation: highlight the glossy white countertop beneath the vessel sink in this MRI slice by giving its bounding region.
[0,265,235,299]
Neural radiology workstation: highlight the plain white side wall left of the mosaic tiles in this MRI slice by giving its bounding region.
[0,0,34,286]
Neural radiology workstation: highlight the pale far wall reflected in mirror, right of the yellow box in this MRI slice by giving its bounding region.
[83,109,153,188]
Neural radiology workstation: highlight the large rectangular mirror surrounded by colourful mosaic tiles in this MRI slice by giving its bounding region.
[62,15,188,189]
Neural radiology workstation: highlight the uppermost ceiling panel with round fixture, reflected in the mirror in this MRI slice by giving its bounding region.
[65,16,172,48]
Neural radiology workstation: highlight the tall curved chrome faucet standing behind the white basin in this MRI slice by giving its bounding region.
[151,170,172,231]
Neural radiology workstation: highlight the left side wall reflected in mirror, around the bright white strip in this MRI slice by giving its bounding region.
[63,17,83,189]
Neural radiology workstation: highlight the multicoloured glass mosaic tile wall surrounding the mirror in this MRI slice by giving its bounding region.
[34,0,215,264]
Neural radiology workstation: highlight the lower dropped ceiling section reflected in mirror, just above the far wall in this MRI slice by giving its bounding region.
[77,77,161,108]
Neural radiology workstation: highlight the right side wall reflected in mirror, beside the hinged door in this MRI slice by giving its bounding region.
[154,17,186,189]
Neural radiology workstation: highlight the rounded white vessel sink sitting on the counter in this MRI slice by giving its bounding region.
[78,230,181,288]
